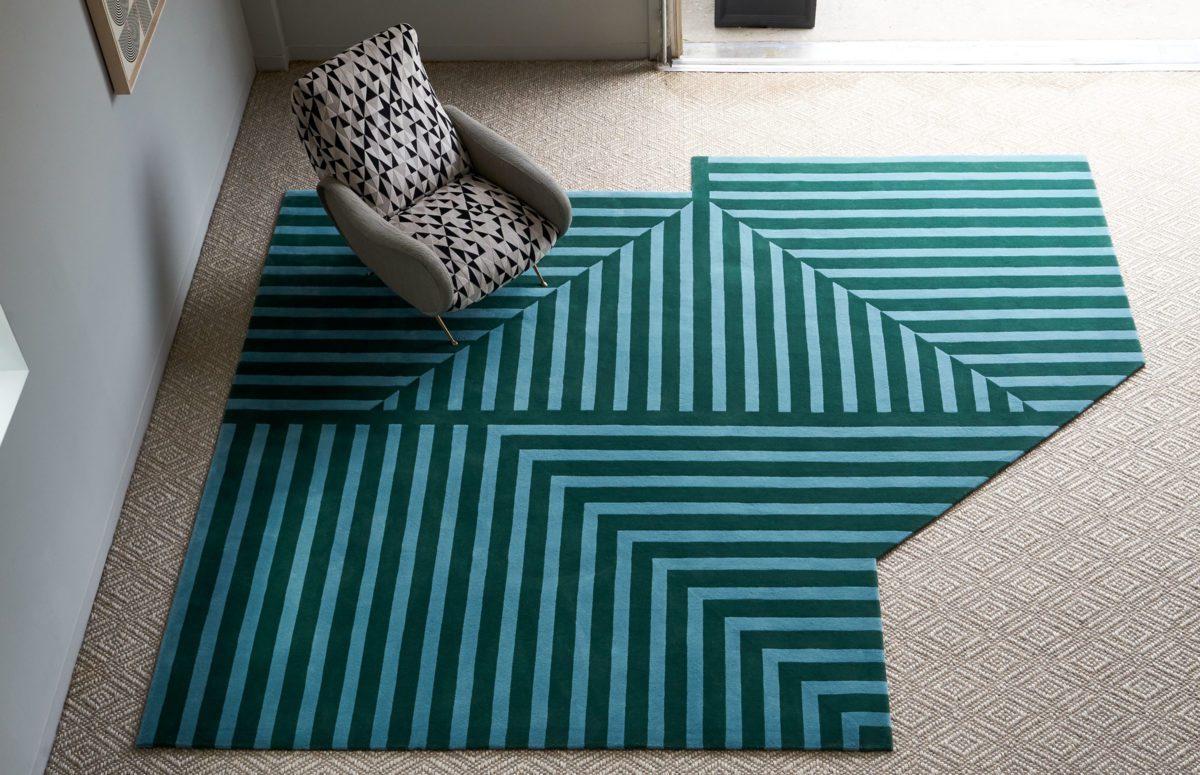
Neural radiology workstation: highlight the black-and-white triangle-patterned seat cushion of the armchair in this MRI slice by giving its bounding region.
[389,173,558,310]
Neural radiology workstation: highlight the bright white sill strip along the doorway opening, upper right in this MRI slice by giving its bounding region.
[665,40,1200,72]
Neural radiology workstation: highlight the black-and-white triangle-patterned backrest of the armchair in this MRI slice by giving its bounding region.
[292,24,469,217]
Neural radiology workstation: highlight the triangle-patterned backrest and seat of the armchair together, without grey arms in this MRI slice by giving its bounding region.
[292,24,558,310]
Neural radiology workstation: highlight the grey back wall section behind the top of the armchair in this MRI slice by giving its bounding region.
[270,0,660,60]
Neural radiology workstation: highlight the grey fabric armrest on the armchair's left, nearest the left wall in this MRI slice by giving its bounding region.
[317,178,454,316]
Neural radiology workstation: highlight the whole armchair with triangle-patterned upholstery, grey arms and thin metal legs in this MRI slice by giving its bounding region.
[292,24,571,344]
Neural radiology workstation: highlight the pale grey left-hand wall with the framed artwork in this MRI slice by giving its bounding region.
[0,0,253,775]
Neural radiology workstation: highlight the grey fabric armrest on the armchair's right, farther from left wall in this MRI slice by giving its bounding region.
[445,106,571,234]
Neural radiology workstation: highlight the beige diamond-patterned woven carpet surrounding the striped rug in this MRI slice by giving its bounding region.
[49,64,1200,774]
